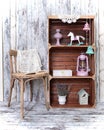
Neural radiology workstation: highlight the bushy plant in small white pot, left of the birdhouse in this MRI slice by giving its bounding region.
[57,84,70,105]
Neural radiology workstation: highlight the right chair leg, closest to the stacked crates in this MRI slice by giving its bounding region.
[43,77,50,110]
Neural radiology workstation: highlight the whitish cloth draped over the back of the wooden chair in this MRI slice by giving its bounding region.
[17,49,42,74]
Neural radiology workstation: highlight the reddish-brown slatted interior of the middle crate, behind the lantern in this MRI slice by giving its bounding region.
[49,46,95,76]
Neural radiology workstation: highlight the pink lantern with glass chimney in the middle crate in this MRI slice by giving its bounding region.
[77,53,89,76]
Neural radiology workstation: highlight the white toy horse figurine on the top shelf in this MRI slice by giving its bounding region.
[67,32,85,46]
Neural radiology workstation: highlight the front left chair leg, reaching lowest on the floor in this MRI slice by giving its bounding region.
[20,79,24,119]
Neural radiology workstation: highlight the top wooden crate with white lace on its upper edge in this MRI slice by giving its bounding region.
[48,16,94,45]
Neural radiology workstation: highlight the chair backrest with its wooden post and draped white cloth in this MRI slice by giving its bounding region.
[9,49,42,74]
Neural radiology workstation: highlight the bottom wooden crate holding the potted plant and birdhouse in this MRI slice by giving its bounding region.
[50,78,95,108]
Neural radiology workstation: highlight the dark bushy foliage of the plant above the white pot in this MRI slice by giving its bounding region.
[57,84,70,96]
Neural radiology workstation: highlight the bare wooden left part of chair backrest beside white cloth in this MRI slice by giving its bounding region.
[9,50,17,73]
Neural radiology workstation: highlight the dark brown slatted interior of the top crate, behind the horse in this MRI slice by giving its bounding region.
[49,18,94,44]
